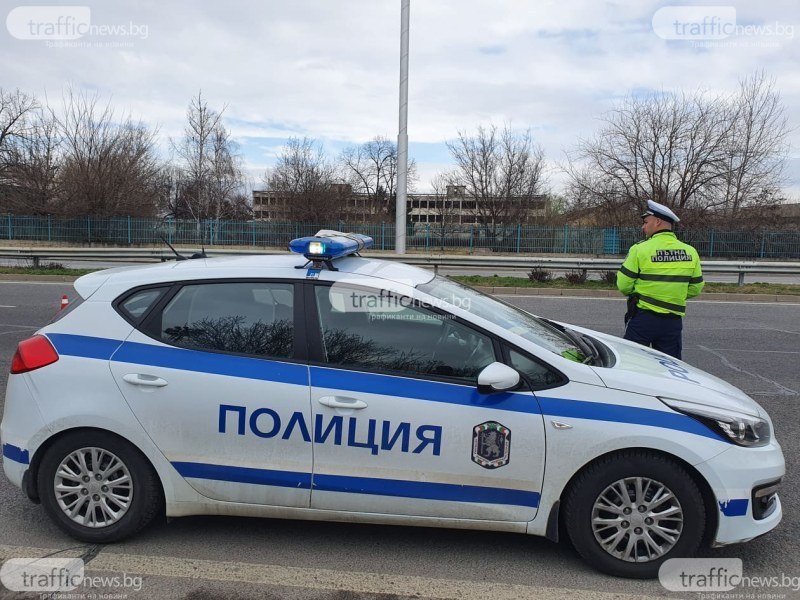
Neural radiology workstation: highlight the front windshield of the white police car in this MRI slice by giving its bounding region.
[417,275,582,362]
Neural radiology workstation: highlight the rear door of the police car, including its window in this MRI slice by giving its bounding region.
[111,280,312,507]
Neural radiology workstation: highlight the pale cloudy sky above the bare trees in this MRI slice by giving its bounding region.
[0,0,800,201]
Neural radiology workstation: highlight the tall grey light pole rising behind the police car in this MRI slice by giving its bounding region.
[394,0,411,254]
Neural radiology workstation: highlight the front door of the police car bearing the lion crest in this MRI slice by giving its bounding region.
[306,282,545,521]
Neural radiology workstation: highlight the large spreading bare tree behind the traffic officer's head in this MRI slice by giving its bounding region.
[566,74,788,224]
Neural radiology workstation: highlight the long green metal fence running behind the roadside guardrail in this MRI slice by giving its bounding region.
[0,214,800,260]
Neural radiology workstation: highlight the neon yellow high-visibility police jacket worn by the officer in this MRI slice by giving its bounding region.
[617,231,704,316]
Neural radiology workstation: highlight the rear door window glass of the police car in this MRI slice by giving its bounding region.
[160,282,294,358]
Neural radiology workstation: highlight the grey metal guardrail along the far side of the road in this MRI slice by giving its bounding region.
[0,247,800,285]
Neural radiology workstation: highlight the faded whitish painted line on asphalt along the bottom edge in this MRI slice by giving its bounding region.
[0,545,652,600]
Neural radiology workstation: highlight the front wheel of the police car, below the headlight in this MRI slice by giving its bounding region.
[564,450,706,579]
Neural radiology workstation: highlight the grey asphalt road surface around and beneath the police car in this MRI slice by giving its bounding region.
[0,281,800,600]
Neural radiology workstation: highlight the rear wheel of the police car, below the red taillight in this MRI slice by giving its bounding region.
[37,431,162,543]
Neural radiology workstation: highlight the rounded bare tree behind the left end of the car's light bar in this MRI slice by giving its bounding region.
[264,138,350,224]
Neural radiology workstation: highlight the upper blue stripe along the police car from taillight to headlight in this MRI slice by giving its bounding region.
[43,333,726,441]
